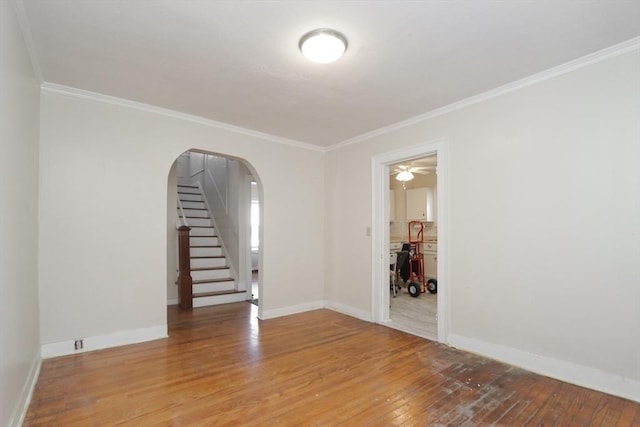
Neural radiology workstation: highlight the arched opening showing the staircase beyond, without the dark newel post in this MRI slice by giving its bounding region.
[166,149,261,314]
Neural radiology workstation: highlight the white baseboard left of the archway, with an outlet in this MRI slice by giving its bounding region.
[40,325,168,359]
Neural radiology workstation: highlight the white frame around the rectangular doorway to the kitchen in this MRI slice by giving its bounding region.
[371,139,450,343]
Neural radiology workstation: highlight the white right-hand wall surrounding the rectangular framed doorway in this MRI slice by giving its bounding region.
[326,50,640,400]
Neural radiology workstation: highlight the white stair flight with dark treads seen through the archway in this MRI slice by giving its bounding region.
[178,185,247,308]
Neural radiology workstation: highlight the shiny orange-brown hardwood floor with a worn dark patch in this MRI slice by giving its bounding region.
[24,303,640,426]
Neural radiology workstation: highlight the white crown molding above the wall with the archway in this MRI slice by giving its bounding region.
[40,82,325,152]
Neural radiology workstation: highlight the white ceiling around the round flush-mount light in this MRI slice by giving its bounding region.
[17,0,640,147]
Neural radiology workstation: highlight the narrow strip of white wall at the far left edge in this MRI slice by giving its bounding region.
[0,1,40,426]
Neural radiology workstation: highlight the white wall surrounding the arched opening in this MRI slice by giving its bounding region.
[40,88,324,352]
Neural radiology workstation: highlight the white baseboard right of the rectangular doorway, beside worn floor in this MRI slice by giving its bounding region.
[448,334,640,402]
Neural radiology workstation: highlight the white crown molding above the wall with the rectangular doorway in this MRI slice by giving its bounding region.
[324,37,640,152]
